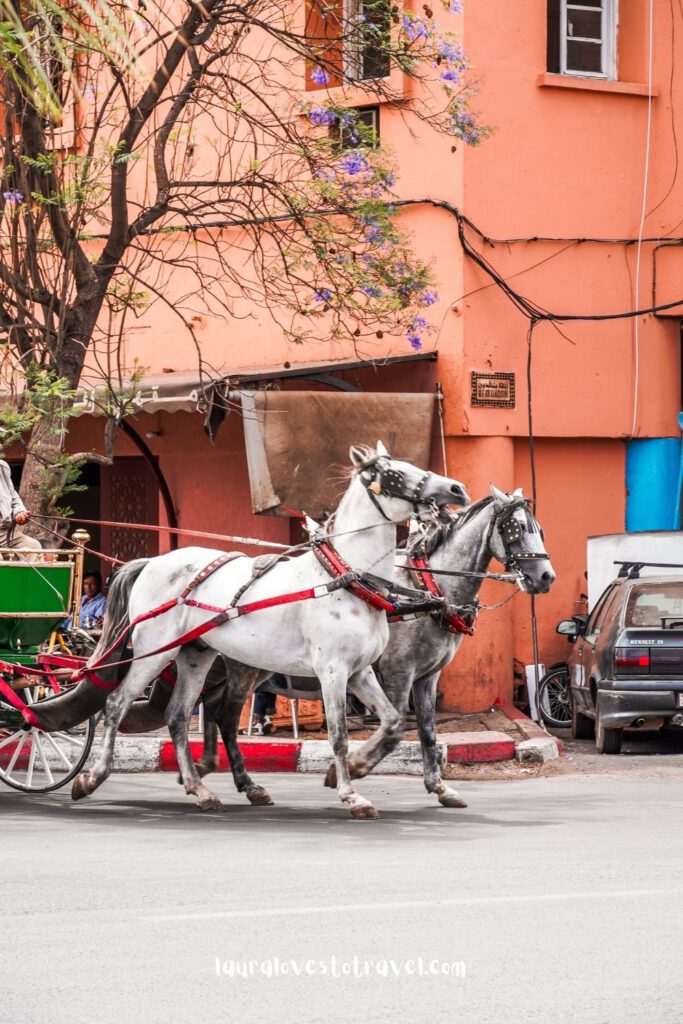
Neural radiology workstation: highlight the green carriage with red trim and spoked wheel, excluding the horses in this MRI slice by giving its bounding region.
[0,548,95,793]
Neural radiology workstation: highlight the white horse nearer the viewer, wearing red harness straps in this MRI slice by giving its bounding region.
[72,441,468,818]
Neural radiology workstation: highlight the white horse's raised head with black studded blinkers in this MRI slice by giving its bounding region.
[349,441,469,522]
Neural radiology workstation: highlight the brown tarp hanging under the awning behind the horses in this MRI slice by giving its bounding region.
[242,391,435,519]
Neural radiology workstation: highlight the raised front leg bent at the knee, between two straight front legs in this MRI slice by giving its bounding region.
[325,668,412,788]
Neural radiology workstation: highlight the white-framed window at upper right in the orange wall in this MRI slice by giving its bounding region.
[548,0,616,79]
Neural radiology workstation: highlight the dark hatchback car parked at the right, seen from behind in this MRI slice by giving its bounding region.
[557,577,683,754]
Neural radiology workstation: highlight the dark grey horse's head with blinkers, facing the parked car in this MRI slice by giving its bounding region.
[488,483,555,594]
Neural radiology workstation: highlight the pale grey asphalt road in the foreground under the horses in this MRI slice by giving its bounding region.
[0,770,683,1024]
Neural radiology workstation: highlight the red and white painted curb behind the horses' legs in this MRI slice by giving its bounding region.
[102,703,561,775]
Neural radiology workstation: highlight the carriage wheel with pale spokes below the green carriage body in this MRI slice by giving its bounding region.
[0,686,95,793]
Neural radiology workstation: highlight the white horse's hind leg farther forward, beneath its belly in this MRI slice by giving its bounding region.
[166,646,223,811]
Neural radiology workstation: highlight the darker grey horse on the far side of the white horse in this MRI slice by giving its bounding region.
[198,485,555,807]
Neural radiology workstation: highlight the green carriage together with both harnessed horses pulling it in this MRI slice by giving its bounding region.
[0,442,555,818]
